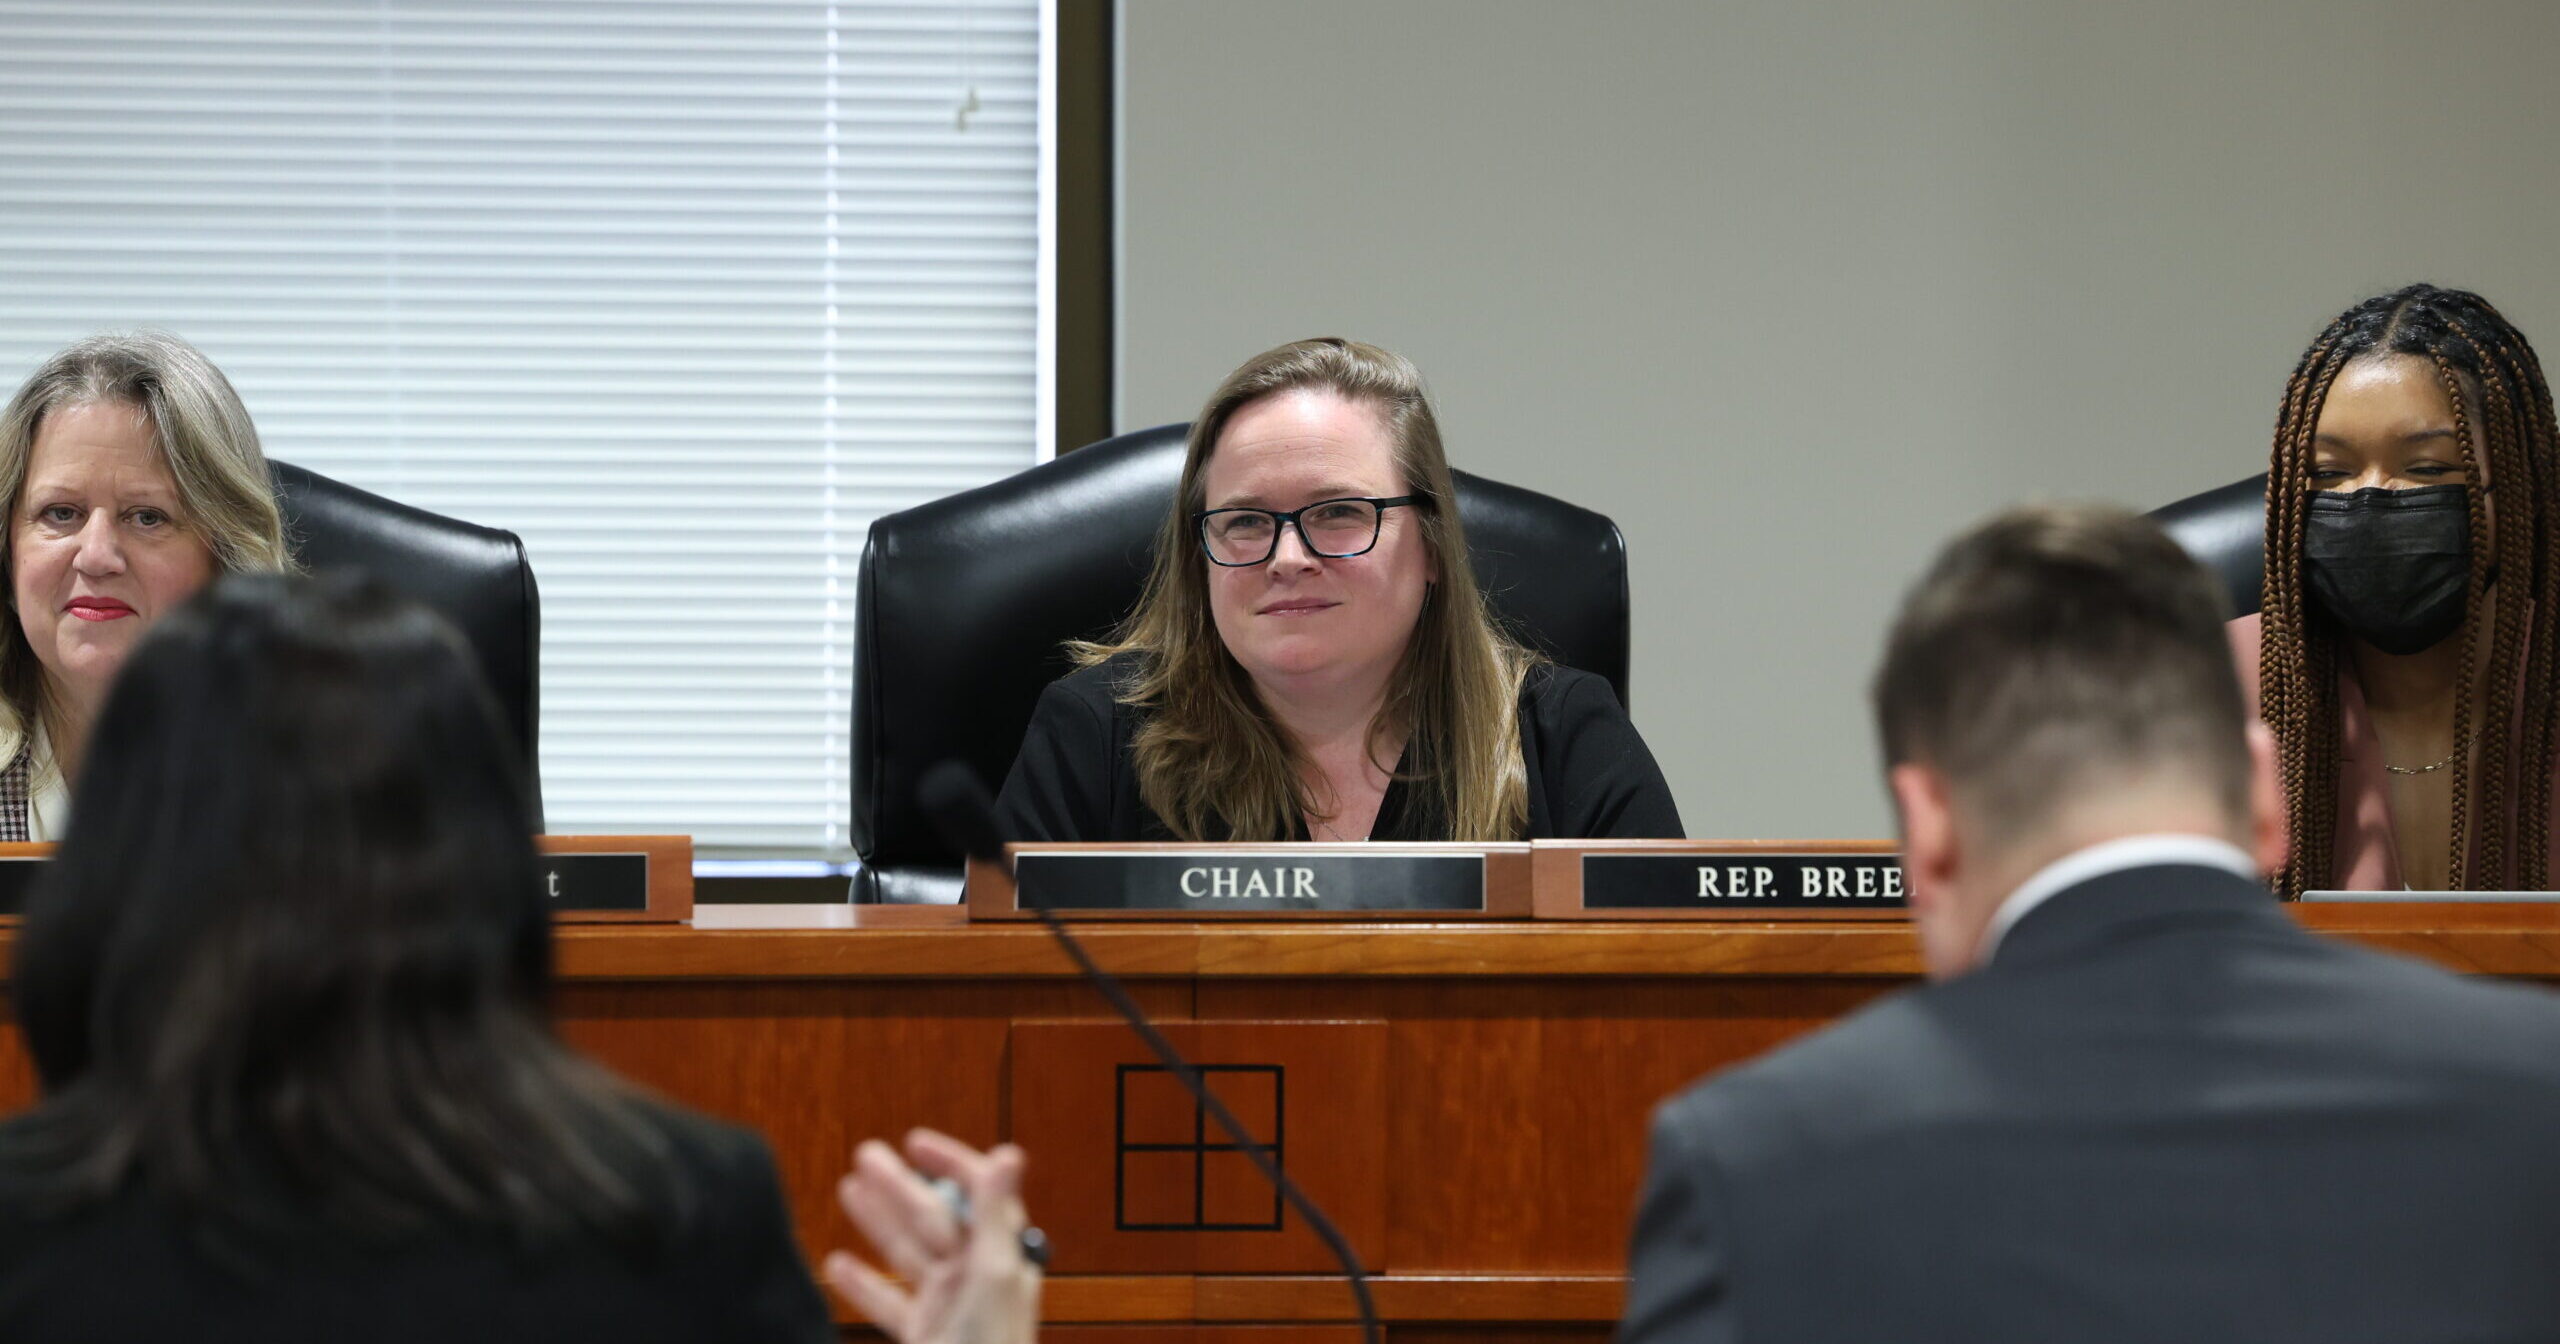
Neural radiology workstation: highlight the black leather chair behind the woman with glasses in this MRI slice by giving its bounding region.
[852,425,1628,904]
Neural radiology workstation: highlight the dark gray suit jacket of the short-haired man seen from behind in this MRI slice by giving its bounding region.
[1620,868,2560,1344]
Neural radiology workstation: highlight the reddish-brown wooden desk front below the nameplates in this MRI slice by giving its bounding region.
[0,906,2560,1344]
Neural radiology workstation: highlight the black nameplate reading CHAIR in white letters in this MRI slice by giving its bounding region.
[1014,850,1485,914]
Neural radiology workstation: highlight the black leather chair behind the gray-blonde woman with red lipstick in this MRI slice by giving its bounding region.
[269,461,543,829]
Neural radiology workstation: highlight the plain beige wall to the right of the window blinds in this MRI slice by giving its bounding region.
[1116,0,2560,837]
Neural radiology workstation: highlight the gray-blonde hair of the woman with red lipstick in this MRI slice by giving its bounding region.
[0,330,294,742]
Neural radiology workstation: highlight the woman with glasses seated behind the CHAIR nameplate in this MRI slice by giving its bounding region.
[998,338,1682,840]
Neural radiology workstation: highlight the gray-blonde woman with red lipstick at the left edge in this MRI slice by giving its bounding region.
[0,333,292,840]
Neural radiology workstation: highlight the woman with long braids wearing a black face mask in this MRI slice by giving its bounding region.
[2232,284,2560,899]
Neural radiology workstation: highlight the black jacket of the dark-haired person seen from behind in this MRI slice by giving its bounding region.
[0,1116,837,1344]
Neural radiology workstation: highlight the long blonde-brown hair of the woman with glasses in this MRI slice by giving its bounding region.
[1070,335,1539,840]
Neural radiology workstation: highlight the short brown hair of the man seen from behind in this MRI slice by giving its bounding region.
[1874,504,2250,842]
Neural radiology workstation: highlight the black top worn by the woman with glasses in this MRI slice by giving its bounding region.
[996,655,1682,840]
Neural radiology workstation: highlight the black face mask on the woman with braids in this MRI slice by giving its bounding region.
[2301,486,2470,653]
